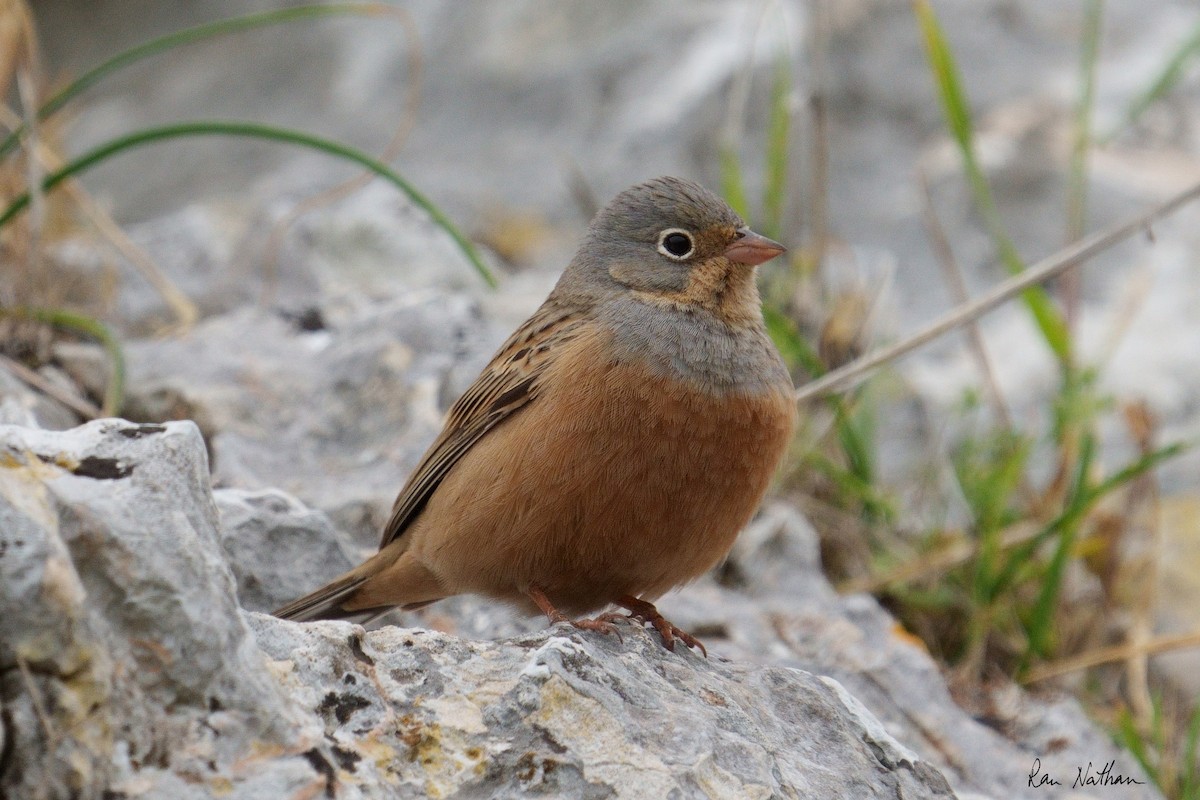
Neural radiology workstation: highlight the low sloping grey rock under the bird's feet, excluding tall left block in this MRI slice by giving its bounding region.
[252,616,953,798]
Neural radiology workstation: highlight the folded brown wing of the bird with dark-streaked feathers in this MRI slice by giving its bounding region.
[379,297,582,549]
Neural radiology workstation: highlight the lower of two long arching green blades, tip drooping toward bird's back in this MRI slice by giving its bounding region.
[0,121,496,287]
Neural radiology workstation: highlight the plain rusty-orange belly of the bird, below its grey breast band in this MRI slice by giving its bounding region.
[410,343,796,613]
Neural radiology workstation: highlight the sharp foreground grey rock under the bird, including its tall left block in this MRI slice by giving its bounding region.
[0,420,969,799]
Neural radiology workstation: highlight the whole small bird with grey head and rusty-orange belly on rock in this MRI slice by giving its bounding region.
[275,178,796,649]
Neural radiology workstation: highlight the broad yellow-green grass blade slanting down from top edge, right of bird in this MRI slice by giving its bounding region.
[913,0,1072,366]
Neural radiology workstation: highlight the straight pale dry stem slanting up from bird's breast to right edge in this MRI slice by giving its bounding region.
[796,178,1200,402]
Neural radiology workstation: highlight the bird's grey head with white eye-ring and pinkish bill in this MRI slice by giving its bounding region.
[564,178,784,295]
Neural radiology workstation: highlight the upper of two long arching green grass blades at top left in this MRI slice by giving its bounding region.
[0,2,391,157]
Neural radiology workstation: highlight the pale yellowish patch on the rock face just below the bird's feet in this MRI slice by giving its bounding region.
[530,675,677,798]
